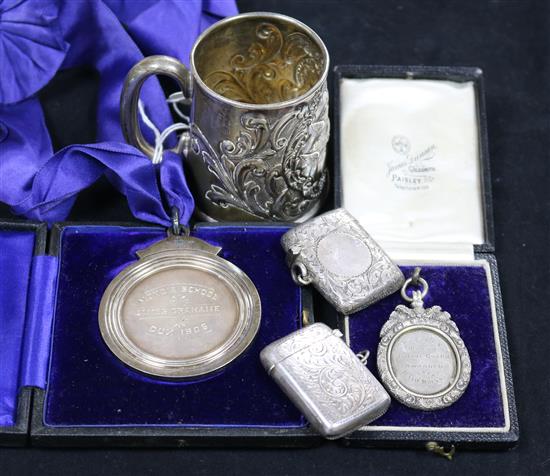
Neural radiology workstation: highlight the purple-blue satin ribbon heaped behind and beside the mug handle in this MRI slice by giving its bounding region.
[0,0,237,225]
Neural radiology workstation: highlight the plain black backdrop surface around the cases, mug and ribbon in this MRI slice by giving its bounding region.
[0,0,550,476]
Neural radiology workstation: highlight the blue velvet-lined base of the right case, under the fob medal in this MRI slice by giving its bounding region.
[340,254,518,448]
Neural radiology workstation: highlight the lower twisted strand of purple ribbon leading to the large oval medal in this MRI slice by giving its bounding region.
[7,142,193,225]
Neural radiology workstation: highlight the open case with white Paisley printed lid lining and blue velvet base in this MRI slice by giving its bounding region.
[333,65,518,448]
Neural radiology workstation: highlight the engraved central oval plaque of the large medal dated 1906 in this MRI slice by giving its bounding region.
[121,269,238,359]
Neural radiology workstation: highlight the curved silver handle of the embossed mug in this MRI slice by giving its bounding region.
[120,55,191,158]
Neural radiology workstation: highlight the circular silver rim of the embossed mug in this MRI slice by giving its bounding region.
[189,12,330,110]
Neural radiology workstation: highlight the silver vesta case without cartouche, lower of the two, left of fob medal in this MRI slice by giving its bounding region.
[260,323,390,439]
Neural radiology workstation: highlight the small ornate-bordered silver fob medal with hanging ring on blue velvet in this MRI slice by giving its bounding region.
[377,269,472,410]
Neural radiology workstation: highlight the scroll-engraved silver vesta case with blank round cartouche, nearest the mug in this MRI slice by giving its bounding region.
[281,208,405,314]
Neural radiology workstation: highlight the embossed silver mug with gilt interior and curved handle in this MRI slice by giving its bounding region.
[121,13,329,221]
